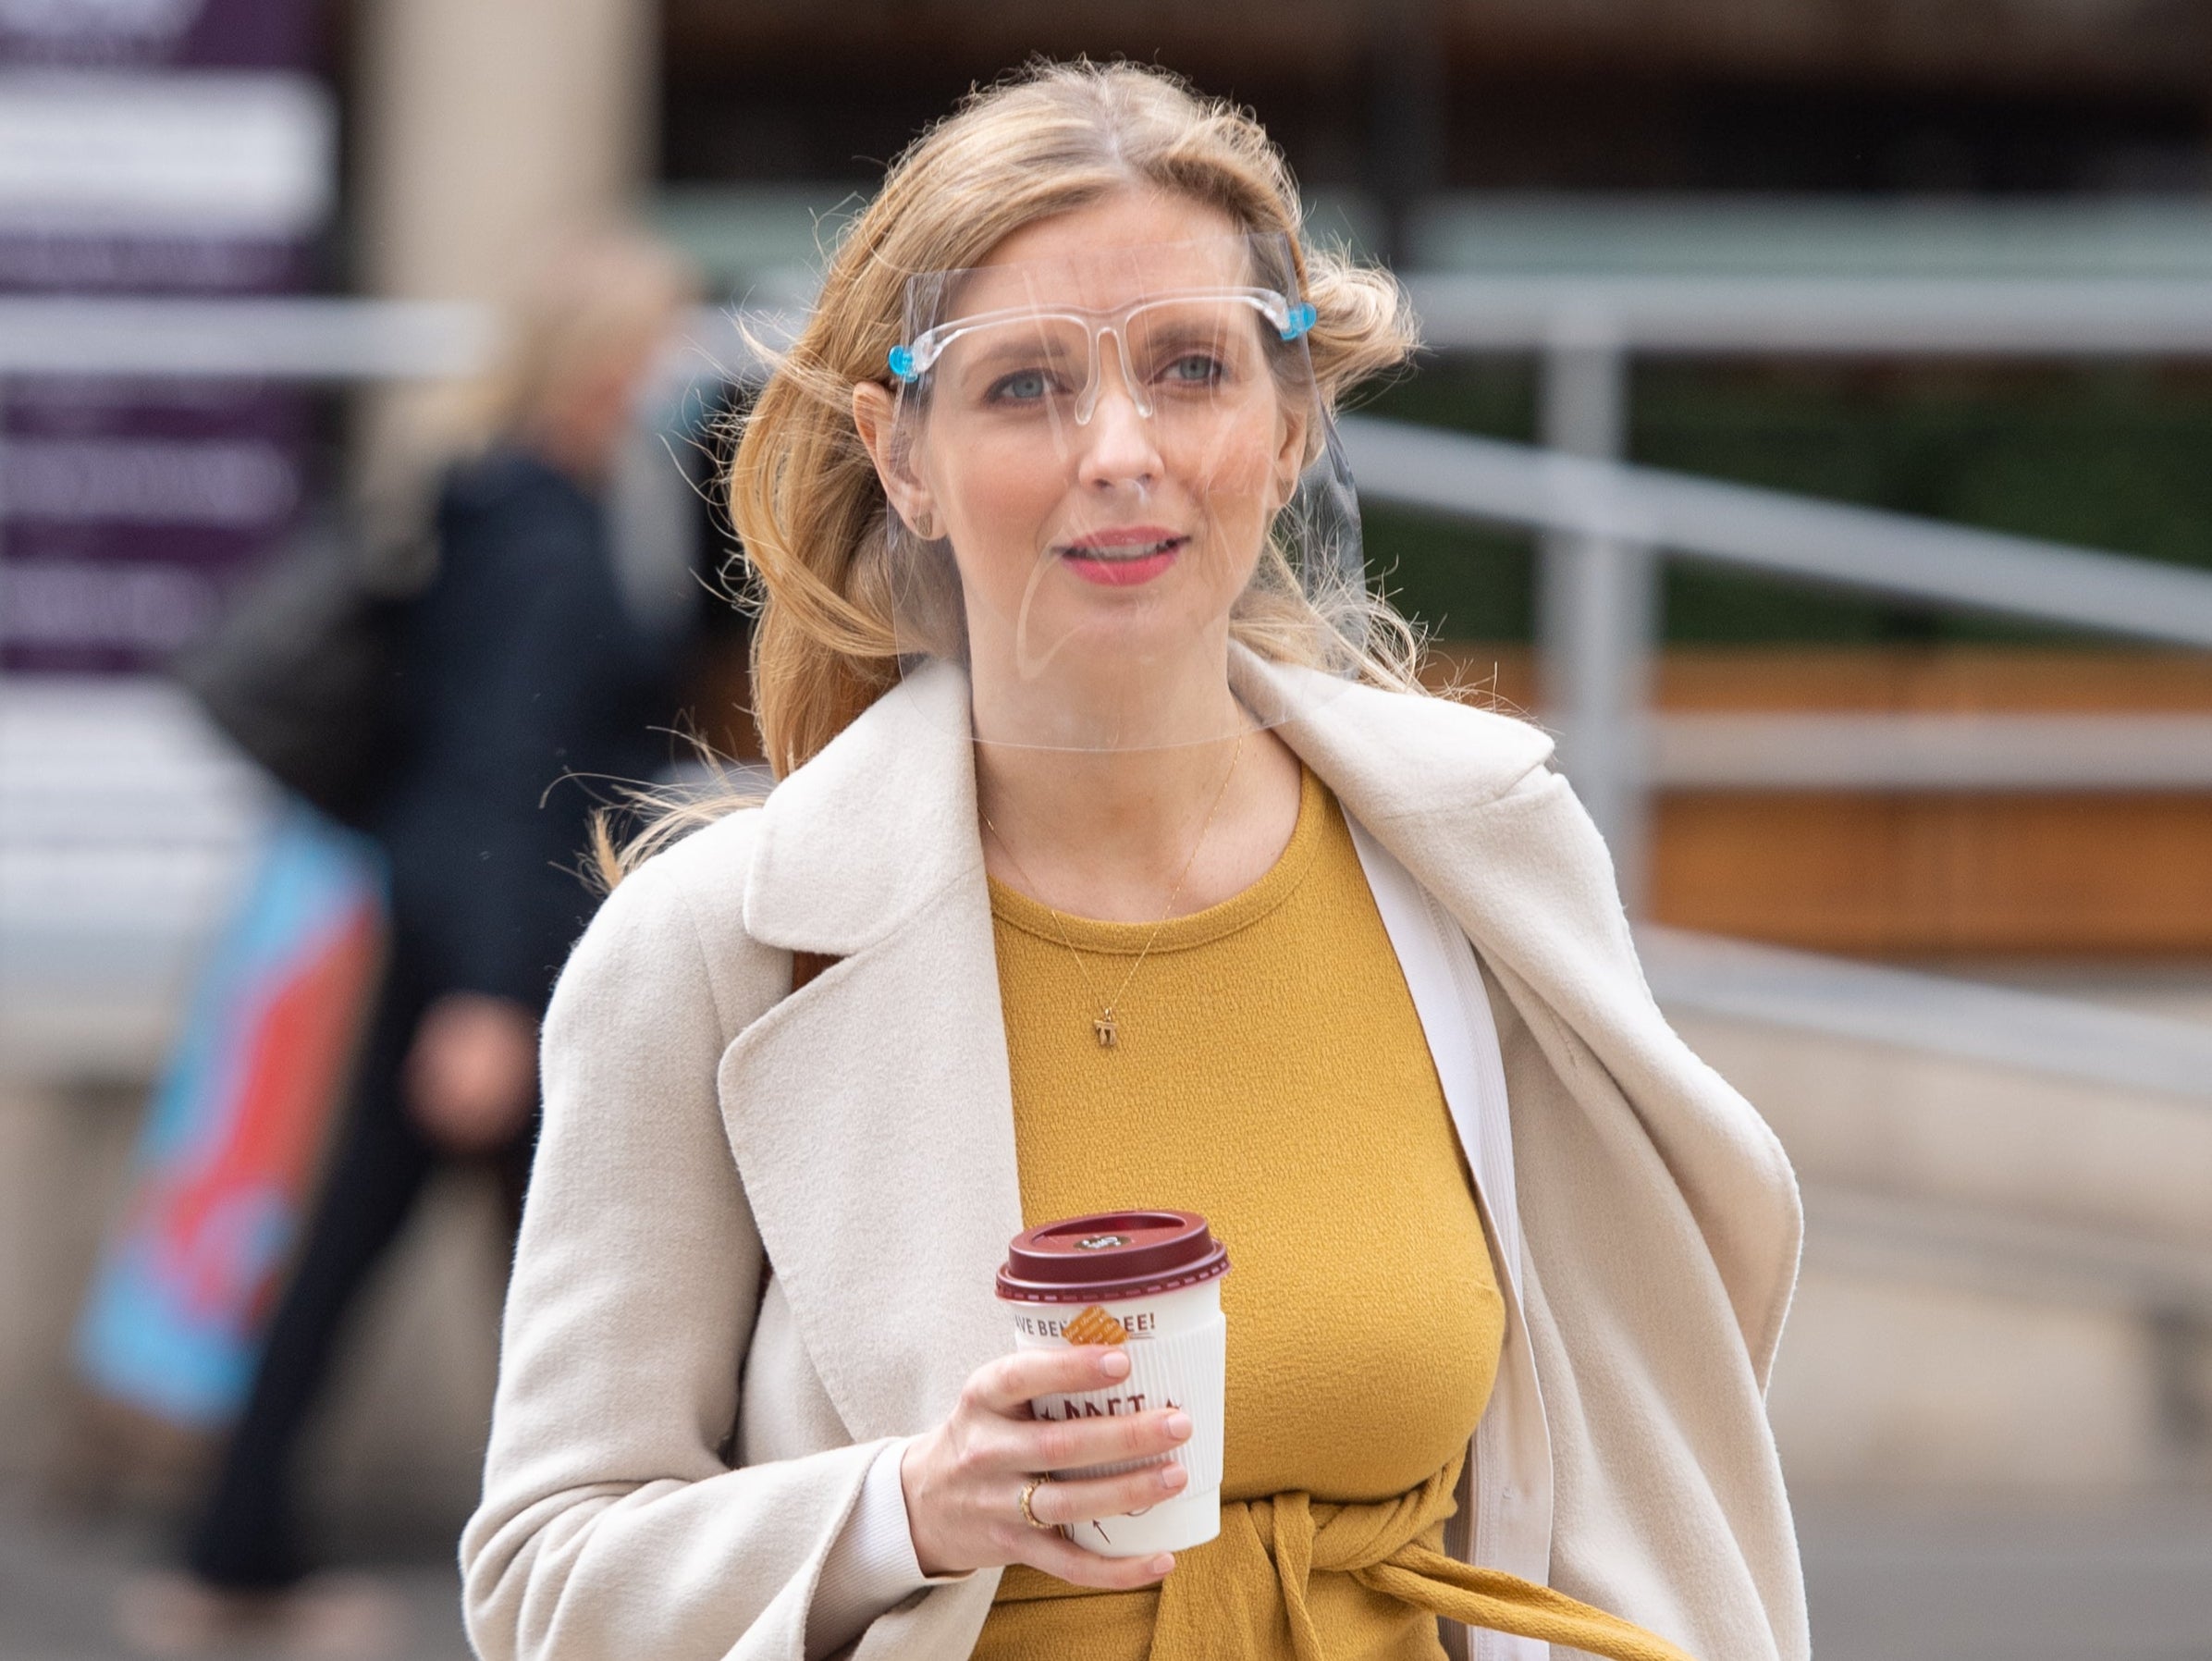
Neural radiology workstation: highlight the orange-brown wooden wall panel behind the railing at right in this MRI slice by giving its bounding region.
[1435,644,2212,958]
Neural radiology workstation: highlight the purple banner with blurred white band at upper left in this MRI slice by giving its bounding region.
[0,0,337,672]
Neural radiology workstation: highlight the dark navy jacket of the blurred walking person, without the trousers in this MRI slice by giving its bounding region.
[374,449,677,1011]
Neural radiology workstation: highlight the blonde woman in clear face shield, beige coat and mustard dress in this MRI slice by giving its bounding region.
[462,64,1807,1661]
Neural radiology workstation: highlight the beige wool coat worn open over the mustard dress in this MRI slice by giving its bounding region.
[462,672,1807,1661]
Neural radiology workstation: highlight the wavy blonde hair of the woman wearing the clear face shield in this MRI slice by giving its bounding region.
[599,62,1420,867]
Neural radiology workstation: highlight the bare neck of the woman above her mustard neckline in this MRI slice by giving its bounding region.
[976,732,1298,922]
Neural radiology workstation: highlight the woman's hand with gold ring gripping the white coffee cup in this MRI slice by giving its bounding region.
[898,1345,1190,1590]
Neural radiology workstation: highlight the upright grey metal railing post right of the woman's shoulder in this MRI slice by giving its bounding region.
[1535,316,1659,916]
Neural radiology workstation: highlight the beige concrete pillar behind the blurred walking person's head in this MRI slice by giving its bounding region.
[354,0,659,489]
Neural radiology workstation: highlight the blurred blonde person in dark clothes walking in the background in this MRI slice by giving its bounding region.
[122,234,694,1655]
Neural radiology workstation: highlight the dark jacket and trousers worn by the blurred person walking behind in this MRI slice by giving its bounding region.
[179,447,675,1601]
